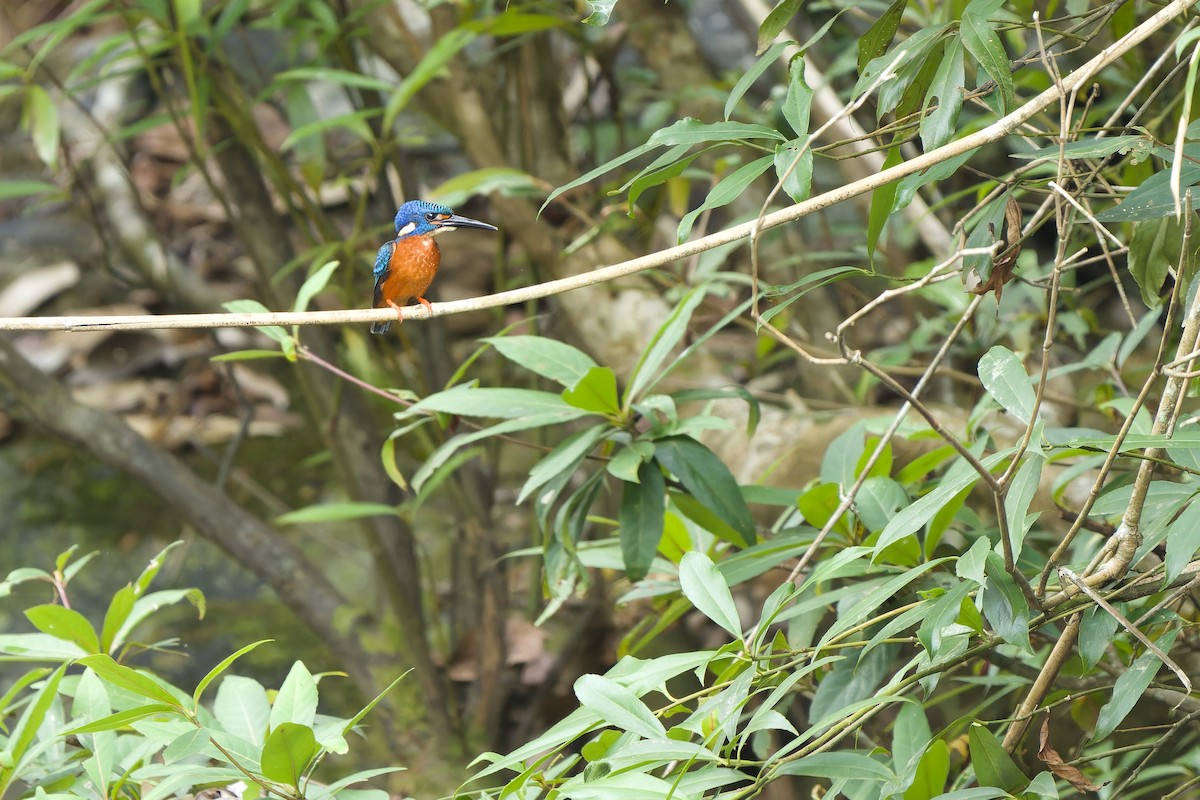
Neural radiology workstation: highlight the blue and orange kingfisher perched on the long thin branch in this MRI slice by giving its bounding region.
[371,200,497,333]
